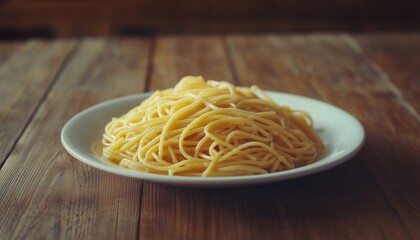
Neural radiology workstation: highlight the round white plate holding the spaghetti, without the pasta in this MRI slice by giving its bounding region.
[61,92,365,187]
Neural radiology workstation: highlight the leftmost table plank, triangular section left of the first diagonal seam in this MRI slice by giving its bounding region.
[0,40,74,166]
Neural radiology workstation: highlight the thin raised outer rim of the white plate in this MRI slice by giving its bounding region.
[60,91,365,187]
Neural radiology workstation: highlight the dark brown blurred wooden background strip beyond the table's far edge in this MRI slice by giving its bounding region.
[0,0,420,38]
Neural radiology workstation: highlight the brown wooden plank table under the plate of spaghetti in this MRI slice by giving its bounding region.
[0,33,420,239]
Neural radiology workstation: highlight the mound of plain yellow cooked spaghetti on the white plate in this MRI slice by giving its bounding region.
[102,76,324,177]
